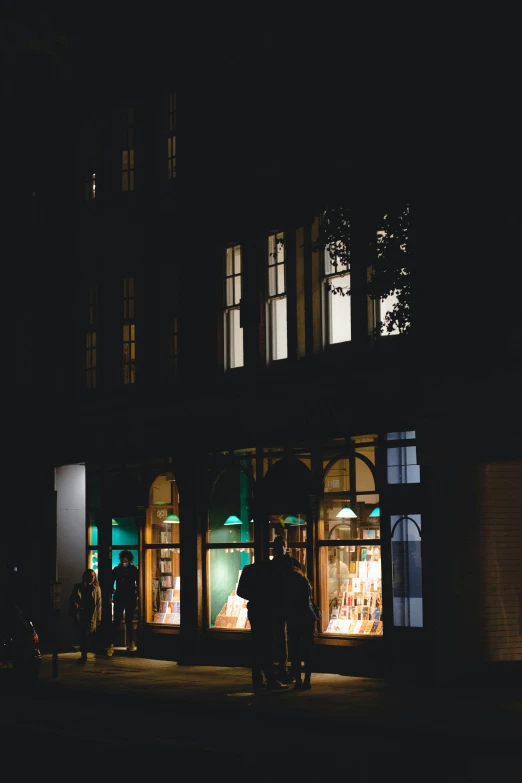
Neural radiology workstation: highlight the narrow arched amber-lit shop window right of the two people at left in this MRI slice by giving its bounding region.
[144,473,181,626]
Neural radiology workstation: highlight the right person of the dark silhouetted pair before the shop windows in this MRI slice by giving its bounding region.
[284,561,316,690]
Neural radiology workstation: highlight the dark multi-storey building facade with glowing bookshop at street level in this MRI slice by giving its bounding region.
[10,35,522,680]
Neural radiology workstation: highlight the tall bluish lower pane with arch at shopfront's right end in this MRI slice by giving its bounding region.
[390,514,423,628]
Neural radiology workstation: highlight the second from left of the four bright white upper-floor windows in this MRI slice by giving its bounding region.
[266,232,288,361]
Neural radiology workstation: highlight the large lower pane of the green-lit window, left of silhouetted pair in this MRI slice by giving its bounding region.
[208,547,254,630]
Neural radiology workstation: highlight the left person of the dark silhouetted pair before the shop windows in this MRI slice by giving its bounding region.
[236,560,288,691]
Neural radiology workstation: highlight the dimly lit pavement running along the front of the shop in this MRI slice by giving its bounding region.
[39,650,522,752]
